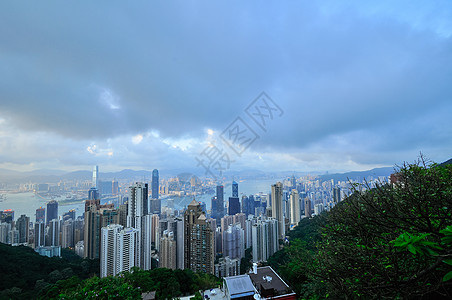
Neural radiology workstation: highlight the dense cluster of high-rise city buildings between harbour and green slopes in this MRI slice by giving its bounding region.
[0,166,378,286]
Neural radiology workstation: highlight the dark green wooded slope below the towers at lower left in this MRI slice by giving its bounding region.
[0,243,220,299]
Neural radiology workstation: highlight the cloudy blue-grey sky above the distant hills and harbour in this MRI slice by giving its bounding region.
[0,0,452,174]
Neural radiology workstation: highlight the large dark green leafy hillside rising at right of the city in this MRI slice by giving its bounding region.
[272,160,452,299]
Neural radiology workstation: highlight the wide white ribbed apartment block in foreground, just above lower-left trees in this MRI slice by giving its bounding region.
[100,224,139,277]
